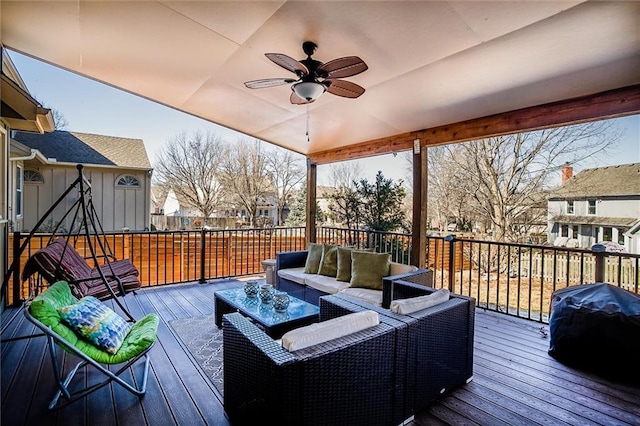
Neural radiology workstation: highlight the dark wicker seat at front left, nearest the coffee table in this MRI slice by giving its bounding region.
[223,313,404,426]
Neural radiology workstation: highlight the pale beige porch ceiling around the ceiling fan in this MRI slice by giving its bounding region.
[0,0,640,154]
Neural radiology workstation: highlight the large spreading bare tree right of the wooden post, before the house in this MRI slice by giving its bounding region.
[440,121,620,241]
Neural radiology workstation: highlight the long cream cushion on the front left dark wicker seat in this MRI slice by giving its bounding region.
[282,311,380,352]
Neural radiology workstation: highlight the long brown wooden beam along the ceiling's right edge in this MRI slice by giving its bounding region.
[307,84,640,164]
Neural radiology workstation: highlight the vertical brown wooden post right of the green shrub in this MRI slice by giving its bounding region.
[411,140,427,268]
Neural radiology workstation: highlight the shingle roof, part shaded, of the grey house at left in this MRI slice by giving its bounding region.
[14,130,151,169]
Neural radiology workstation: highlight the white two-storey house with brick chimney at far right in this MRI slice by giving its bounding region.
[548,163,640,253]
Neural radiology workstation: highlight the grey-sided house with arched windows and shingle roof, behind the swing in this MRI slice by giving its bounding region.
[14,130,153,231]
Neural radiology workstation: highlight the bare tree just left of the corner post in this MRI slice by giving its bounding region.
[265,148,305,225]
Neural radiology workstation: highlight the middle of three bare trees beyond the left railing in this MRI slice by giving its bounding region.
[219,139,272,225]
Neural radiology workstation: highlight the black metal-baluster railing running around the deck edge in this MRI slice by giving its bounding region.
[7,227,640,322]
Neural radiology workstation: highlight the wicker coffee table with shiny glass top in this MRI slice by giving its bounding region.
[214,288,320,339]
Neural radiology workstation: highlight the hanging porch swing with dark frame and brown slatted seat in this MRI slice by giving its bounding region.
[16,164,141,321]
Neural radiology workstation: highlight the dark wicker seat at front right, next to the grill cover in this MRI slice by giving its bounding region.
[320,280,475,424]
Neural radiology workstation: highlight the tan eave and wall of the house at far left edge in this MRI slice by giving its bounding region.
[0,45,55,311]
